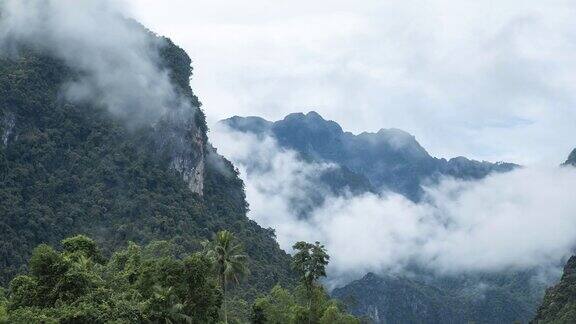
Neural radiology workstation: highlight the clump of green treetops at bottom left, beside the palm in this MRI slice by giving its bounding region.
[0,236,222,323]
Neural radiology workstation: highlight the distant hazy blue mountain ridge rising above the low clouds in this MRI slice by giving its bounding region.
[221,112,517,201]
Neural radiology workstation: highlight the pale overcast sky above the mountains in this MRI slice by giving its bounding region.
[126,0,576,165]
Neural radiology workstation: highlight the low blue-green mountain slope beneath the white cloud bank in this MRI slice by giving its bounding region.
[332,273,543,324]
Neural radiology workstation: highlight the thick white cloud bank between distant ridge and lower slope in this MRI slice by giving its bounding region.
[212,124,576,282]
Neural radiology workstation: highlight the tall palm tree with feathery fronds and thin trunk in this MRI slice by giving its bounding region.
[204,230,248,323]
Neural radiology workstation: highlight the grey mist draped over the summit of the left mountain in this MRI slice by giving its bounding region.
[0,0,191,124]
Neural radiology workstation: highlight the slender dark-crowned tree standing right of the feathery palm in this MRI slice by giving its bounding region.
[292,241,330,323]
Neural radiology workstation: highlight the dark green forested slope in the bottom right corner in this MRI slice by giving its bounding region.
[533,256,576,324]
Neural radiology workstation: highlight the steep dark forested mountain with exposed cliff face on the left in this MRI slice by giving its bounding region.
[0,29,294,298]
